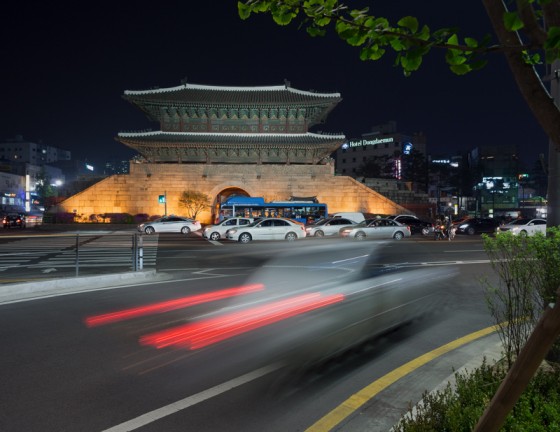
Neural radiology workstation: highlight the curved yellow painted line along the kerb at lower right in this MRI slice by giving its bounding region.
[306,326,498,432]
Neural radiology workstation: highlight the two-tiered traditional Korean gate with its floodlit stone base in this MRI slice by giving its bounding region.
[54,83,405,223]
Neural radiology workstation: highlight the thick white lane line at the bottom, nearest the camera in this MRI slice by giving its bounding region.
[103,363,282,432]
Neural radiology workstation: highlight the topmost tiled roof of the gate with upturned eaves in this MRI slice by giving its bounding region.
[123,83,342,127]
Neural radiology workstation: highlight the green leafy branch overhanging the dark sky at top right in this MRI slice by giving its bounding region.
[238,0,560,76]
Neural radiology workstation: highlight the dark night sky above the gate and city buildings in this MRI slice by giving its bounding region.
[0,0,548,169]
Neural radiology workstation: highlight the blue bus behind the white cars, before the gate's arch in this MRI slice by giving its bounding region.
[219,196,328,224]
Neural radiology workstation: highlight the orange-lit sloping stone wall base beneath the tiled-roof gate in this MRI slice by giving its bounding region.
[49,164,409,223]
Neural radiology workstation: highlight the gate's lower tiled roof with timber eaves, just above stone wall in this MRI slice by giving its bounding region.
[116,131,346,164]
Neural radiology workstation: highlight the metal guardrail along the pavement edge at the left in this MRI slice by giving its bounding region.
[0,230,147,284]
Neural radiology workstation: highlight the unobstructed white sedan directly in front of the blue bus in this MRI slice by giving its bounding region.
[226,218,305,243]
